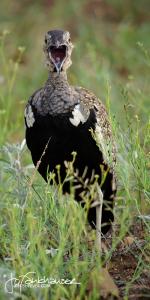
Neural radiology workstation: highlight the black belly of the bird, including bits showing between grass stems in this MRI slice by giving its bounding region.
[26,113,113,233]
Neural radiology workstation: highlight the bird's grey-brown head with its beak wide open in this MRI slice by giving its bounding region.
[43,30,73,74]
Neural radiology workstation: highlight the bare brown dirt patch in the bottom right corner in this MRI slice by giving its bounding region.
[107,220,150,300]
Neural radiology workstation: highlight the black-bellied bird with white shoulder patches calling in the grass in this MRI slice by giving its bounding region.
[24,29,117,244]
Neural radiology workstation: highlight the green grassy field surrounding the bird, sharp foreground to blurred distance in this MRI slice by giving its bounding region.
[0,0,150,299]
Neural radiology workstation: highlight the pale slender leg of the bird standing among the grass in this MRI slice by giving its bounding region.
[91,184,103,252]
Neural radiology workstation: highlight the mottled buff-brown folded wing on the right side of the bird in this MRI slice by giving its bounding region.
[75,87,116,170]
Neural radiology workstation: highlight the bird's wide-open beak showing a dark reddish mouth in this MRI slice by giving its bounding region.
[48,45,67,73]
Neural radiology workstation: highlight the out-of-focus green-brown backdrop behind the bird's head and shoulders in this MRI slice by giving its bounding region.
[0,0,150,143]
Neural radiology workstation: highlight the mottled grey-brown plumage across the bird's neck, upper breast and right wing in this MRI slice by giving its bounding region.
[29,72,116,168]
